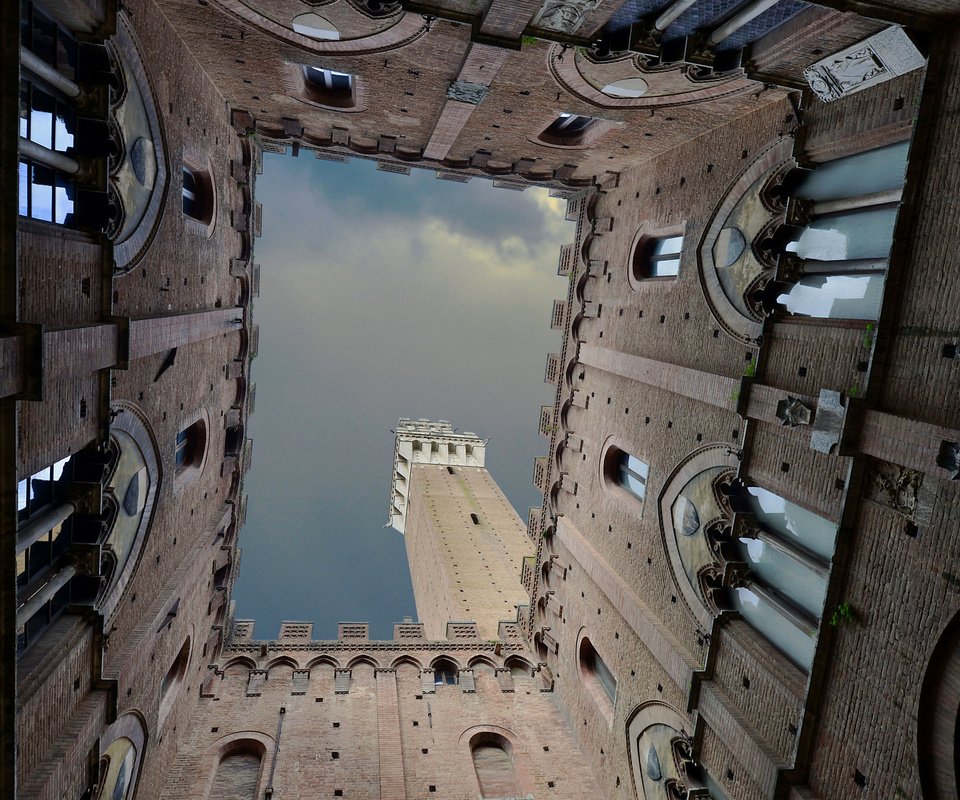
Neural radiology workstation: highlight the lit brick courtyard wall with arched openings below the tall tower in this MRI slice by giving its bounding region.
[159,641,598,800]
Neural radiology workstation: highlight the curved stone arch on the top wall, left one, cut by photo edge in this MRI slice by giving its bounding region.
[216,0,427,55]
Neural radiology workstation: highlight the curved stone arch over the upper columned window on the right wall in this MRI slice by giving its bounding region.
[697,137,793,344]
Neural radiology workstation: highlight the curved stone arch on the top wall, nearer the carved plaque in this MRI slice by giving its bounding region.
[547,44,756,110]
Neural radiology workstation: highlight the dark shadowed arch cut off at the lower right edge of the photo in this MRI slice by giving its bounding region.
[917,612,960,800]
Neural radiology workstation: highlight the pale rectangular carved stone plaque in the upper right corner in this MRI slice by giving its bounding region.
[803,26,926,103]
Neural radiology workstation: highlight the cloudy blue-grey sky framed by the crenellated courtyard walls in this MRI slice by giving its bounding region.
[234,152,575,639]
